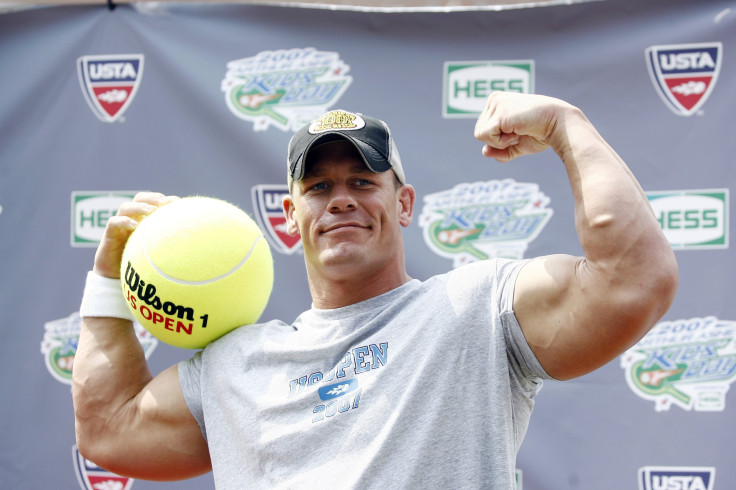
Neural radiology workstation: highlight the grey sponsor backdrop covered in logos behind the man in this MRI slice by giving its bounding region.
[0,0,736,490]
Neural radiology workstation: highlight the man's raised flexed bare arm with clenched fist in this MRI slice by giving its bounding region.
[475,93,677,379]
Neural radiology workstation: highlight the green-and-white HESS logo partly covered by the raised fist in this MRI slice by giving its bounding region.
[442,60,534,118]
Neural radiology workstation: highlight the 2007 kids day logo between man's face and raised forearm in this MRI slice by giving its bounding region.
[419,179,552,267]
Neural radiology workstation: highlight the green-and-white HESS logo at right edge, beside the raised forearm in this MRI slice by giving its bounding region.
[647,189,728,250]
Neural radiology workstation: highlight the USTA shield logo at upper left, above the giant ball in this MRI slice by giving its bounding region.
[77,54,143,123]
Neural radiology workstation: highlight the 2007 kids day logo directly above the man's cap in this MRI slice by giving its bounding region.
[221,48,353,131]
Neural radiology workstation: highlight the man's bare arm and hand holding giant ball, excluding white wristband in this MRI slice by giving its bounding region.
[72,193,210,480]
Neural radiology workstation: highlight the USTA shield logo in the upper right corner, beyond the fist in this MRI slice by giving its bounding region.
[646,43,723,116]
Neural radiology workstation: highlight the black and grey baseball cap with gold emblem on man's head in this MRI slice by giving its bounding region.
[287,110,406,187]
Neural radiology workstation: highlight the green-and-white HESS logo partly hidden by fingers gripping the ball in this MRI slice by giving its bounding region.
[71,191,136,247]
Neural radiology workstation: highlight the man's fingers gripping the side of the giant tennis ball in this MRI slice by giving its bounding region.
[93,192,179,278]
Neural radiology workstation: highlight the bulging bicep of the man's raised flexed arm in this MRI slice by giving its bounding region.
[514,255,641,379]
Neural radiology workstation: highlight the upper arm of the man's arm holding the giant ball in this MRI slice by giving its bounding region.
[95,365,211,480]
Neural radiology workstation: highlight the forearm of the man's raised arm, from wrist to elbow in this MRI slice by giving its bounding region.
[553,109,677,338]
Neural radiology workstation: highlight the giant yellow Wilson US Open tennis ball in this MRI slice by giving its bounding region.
[120,197,273,349]
